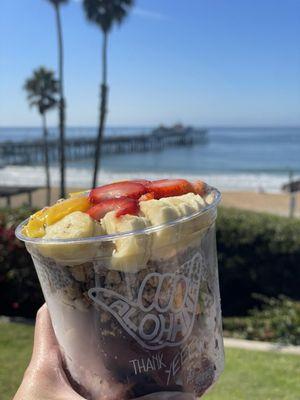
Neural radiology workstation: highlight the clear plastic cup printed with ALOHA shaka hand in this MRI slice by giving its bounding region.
[16,188,224,400]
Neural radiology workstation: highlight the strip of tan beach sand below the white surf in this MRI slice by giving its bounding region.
[0,188,300,217]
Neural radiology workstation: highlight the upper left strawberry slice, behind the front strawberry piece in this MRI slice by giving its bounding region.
[89,181,147,204]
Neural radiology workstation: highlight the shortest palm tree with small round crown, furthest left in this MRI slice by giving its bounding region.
[24,67,59,204]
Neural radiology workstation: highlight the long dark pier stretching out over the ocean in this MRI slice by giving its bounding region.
[0,127,207,165]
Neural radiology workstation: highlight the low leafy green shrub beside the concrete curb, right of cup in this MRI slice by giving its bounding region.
[223,295,300,345]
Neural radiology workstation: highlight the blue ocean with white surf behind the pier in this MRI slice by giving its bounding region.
[0,127,300,192]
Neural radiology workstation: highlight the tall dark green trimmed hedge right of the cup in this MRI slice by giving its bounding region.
[217,208,300,316]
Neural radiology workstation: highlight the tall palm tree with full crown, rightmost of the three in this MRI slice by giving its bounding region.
[83,0,134,187]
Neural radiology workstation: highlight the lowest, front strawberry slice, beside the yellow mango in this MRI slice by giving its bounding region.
[86,197,139,221]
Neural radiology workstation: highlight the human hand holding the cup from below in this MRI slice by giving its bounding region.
[13,304,194,400]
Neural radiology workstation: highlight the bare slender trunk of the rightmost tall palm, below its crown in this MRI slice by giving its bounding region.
[92,32,108,188]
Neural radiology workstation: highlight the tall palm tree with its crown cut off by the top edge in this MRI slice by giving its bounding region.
[48,0,69,198]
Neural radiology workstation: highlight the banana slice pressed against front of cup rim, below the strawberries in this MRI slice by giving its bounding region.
[102,211,151,272]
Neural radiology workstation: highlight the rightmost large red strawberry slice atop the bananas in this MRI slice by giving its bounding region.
[147,179,194,199]
